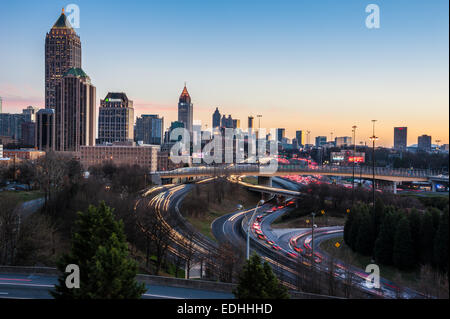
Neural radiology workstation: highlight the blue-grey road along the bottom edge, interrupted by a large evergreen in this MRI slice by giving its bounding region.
[0,273,234,299]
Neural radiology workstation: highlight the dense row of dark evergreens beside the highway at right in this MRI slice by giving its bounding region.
[344,200,449,273]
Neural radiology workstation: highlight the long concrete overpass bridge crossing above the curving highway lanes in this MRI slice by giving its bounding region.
[153,164,449,193]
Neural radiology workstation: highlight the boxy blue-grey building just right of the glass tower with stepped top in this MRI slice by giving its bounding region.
[134,114,164,145]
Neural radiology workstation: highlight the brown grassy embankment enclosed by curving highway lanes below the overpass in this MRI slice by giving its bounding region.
[181,182,261,241]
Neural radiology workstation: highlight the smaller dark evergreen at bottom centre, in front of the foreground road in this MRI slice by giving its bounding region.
[233,254,289,299]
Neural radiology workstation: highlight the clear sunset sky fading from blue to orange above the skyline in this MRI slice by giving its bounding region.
[0,0,449,146]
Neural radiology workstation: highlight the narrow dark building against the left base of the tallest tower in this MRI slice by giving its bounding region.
[35,109,56,151]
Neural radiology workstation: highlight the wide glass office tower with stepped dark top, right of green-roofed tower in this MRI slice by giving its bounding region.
[97,92,134,144]
